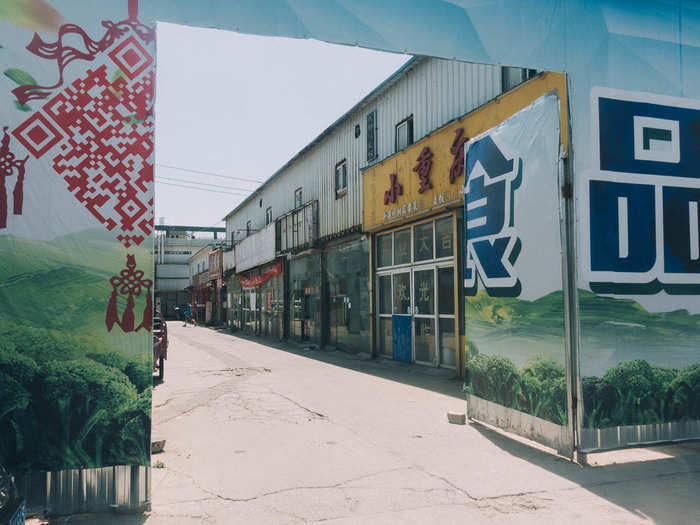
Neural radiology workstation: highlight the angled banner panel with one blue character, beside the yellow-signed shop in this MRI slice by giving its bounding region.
[464,93,569,432]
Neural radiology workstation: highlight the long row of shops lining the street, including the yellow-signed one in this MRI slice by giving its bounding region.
[201,59,566,373]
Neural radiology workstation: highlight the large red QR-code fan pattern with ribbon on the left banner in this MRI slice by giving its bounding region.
[12,0,155,248]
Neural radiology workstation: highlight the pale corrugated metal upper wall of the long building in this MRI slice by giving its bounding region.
[226,58,501,239]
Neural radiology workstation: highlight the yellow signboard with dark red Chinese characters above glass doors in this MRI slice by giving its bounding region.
[362,73,568,231]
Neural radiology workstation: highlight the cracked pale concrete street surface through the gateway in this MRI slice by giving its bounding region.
[39,322,700,525]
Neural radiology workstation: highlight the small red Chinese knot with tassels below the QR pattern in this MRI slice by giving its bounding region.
[105,255,153,333]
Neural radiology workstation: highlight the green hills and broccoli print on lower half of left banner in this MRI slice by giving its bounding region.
[0,229,153,472]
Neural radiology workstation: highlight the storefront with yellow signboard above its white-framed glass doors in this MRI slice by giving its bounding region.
[362,73,567,374]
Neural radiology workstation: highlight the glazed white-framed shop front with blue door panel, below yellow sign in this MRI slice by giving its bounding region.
[375,211,459,367]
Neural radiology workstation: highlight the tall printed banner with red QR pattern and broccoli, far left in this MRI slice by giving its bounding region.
[0,0,155,472]
